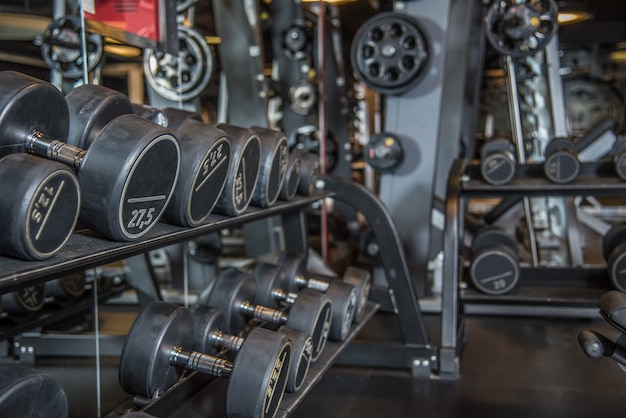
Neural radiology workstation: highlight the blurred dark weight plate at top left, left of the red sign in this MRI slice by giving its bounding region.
[36,15,104,79]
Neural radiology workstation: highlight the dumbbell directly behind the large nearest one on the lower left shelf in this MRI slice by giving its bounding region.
[189,304,313,393]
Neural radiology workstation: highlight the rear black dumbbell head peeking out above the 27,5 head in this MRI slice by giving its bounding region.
[65,84,134,149]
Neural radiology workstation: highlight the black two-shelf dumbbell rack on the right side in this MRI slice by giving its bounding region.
[442,159,626,366]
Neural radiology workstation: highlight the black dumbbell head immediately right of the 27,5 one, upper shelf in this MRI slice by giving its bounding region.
[163,119,231,226]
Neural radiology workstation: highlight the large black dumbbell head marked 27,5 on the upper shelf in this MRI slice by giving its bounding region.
[78,115,180,241]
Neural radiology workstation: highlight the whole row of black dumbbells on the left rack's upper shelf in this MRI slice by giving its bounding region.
[0,71,319,260]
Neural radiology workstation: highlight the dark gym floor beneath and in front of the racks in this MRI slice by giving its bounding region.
[39,306,626,418]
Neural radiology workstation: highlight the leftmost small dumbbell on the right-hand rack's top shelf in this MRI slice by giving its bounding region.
[480,138,517,186]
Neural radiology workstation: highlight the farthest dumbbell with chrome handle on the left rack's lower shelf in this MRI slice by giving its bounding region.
[276,252,372,323]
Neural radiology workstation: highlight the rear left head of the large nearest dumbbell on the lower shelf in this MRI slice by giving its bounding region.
[119,302,193,398]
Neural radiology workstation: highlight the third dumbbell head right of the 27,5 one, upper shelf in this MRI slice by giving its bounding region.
[250,126,289,208]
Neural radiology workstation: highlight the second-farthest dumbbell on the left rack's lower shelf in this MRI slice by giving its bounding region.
[252,262,357,341]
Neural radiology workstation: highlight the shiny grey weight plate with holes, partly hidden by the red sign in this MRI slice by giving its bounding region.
[143,25,213,102]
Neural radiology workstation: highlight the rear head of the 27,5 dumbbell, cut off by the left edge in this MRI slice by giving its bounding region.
[0,70,70,157]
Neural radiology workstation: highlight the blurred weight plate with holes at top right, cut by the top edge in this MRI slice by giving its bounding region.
[485,0,558,58]
